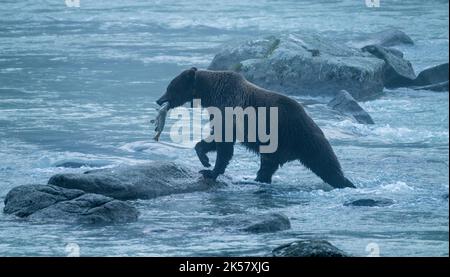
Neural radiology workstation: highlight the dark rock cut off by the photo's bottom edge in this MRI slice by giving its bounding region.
[272,240,349,257]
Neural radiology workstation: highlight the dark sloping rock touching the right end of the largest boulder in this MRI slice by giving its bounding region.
[362,45,416,88]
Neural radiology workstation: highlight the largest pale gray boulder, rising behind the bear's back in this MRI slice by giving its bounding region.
[209,32,384,99]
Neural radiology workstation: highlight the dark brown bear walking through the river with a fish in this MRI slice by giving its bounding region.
[157,67,355,188]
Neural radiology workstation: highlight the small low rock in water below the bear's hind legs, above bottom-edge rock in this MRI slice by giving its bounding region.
[243,213,291,233]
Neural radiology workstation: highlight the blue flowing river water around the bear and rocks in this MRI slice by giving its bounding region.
[0,0,449,256]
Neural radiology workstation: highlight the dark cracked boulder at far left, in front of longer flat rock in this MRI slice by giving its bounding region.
[3,185,138,224]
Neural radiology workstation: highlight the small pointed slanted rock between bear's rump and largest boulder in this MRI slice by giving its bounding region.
[328,90,374,124]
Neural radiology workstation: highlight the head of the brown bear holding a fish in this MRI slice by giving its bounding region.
[156,67,197,109]
